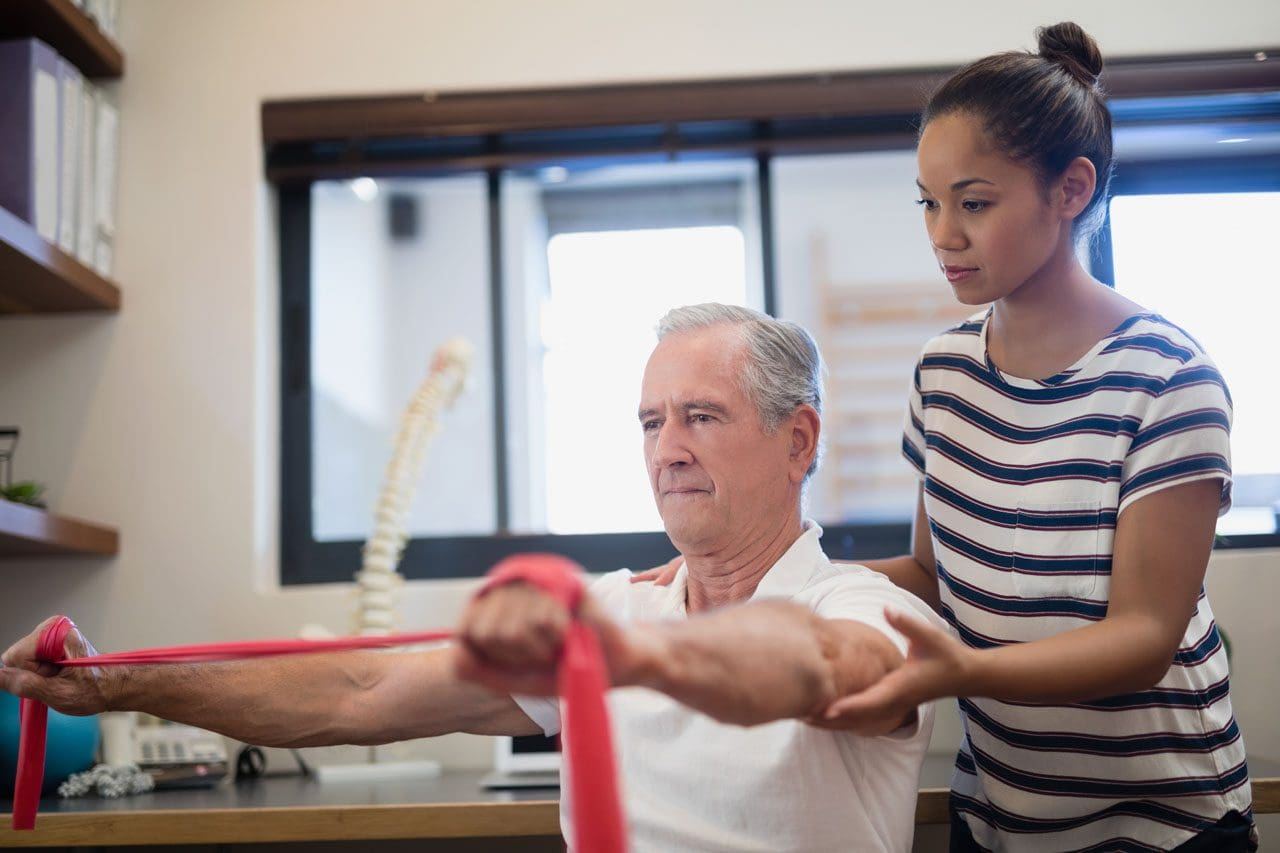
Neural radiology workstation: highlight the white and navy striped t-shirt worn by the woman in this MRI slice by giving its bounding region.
[902,311,1252,852]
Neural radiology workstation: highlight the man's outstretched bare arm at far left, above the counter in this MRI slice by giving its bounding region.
[0,617,540,747]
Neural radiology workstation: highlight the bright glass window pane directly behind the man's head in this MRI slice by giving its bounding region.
[504,161,762,533]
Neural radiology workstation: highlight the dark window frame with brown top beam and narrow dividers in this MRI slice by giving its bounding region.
[275,50,1280,585]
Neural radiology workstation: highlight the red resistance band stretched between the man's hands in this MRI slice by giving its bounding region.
[13,553,627,853]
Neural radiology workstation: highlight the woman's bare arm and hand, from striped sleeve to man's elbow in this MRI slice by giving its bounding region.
[828,479,1221,720]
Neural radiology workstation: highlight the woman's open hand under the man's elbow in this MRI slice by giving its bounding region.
[810,611,977,734]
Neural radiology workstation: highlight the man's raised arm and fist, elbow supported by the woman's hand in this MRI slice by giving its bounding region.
[460,584,914,734]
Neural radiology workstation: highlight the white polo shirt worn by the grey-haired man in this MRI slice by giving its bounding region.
[516,521,948,853]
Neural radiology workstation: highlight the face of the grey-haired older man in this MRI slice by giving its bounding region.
[640,325,803,556]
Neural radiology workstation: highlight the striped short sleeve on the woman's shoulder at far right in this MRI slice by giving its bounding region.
[1117,359,1231,515]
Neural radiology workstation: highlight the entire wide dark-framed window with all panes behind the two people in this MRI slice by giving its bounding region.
[275,59,1280,583]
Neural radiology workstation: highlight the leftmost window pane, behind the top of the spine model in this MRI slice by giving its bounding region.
[311,175,495,542]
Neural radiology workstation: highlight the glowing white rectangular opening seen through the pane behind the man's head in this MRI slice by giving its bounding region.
[543,225,746,533]
